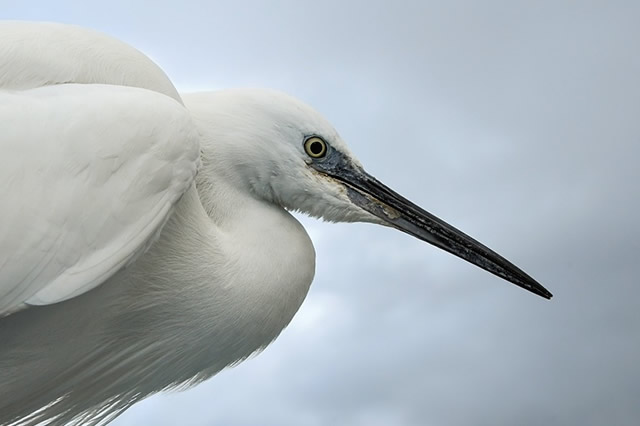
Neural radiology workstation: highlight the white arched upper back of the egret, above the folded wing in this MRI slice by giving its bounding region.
[0,21,180,101]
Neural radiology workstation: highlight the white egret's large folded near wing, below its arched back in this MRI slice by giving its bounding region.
[0,84,199,314]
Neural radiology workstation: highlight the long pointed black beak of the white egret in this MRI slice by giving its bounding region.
[316,158,553,299]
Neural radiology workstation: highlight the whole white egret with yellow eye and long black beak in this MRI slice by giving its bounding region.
[0,22,551,425]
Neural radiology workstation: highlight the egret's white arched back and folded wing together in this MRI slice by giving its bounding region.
[0,21,199,315]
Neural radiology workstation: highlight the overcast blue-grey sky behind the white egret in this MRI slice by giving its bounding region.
[0,0,640,426]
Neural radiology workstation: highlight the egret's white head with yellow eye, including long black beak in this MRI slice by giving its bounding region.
[185,89,552,298]
